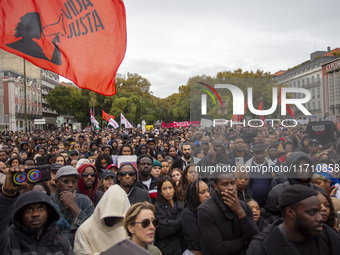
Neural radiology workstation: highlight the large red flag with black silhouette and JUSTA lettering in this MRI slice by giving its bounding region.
[0,0,126,96]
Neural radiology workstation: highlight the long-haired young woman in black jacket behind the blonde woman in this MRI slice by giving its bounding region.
[155,175,186,255]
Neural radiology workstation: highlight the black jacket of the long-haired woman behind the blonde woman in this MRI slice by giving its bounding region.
[155,201,186,255]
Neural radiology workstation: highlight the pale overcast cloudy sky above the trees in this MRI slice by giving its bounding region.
[61,0,340,98]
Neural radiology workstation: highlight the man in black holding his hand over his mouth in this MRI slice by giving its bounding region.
[197,172,259,255]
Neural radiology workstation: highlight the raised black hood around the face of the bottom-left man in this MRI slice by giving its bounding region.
[12,191,60,229]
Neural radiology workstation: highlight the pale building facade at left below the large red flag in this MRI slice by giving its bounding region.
[0,49,59,131]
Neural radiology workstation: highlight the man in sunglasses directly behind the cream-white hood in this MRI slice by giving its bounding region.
[116,164,151,205]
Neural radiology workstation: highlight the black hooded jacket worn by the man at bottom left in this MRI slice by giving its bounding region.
[0,191,73,255]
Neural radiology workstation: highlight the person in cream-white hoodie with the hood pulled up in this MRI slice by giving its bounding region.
[74,185,130,255]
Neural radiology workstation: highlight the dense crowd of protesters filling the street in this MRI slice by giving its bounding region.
[0,125,340,255]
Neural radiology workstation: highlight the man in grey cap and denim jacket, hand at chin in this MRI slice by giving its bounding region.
[50,166,94,245]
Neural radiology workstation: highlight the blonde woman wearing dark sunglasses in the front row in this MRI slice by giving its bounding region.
[124,202,162,255]
